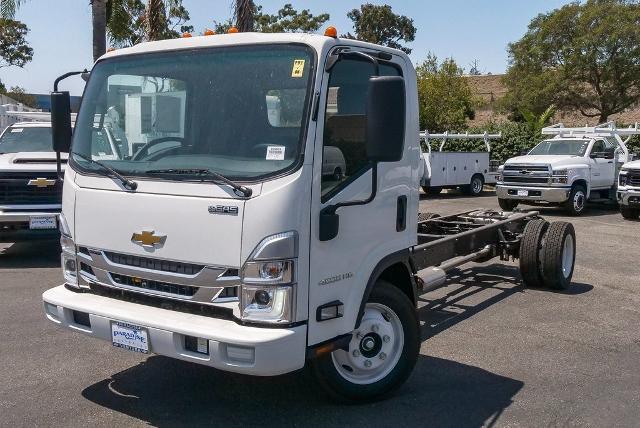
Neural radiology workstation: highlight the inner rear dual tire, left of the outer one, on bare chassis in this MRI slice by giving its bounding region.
[519,219,549,288]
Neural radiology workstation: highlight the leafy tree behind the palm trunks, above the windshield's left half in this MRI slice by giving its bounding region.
[107,0,193,48]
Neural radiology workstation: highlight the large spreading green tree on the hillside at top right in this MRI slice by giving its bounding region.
[503,0,640,122]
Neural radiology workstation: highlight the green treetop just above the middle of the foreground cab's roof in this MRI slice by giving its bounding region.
[215,3,329,34]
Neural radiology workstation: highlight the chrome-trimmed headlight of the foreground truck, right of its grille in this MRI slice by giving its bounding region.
[240,232,298,324]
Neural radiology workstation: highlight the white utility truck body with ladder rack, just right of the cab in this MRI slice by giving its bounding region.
[420,131,501,196]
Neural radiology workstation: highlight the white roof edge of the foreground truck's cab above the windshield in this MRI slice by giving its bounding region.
[98,33,406,61]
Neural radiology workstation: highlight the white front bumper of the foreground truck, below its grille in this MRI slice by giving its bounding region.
[42,285,307,376]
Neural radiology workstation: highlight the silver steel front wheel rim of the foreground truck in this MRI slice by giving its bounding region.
[331,303,404,385]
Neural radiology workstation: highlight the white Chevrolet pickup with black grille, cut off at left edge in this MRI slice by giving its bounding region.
[0,122,66,242]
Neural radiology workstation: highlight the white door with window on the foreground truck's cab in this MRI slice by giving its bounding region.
[305,51,420,345]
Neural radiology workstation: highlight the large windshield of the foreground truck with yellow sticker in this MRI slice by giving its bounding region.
[71,44,315,181]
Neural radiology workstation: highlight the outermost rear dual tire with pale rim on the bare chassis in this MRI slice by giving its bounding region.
[542,221,576,290]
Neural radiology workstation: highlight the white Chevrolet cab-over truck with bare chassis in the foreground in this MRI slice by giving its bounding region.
[43,33,576,401]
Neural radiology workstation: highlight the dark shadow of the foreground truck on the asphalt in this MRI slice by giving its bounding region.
[76,264,593,426]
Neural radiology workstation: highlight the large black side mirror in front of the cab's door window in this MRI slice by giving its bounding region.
[367,76,406,162]
